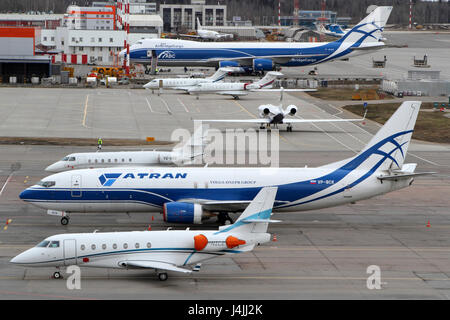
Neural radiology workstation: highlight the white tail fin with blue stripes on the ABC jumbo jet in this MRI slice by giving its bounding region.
[337,6,392,47]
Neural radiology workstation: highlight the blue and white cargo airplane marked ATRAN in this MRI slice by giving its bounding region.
[20,101,432,224]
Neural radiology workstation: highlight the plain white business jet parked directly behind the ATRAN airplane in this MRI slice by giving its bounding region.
[45,125,208,172]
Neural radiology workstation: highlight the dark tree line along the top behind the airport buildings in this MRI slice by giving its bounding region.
[0,0,450,25]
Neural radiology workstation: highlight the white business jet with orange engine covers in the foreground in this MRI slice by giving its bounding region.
[11,187,278,281]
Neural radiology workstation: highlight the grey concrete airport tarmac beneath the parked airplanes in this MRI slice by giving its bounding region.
[0,84,450,299]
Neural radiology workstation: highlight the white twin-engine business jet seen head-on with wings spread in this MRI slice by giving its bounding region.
[199,104,367,132]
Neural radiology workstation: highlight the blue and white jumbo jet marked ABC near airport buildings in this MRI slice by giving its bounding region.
[120,7,392,71]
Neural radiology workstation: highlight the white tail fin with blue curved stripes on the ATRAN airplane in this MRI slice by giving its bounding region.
[324,101,422,171]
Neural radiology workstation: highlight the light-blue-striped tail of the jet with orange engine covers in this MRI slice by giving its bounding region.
[219,187,279,234]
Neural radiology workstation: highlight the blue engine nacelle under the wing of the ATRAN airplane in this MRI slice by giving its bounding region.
[163,202,203,224]
